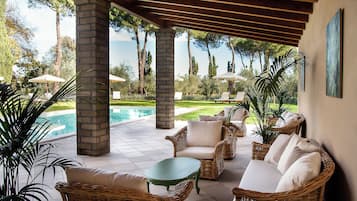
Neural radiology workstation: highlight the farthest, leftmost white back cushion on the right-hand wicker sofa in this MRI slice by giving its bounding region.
[264,134,291,165]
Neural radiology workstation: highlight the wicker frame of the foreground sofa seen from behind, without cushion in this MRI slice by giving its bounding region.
[56,181,193,201]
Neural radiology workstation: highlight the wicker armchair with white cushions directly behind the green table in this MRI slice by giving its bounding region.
[165,121,230,180]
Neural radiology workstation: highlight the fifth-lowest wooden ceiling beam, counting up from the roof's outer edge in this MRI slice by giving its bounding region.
[137,0,309,23]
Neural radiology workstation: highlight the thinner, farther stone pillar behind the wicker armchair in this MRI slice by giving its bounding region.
[156,28,175,128]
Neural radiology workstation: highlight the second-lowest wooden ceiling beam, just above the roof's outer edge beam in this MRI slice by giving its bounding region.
[162,17,300,41]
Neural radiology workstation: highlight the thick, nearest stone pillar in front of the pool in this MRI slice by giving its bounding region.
[75,0,110,156]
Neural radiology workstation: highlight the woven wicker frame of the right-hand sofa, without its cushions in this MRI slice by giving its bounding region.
[232,142,335,201]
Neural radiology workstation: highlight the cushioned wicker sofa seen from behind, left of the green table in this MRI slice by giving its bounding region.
[56,168,193,201]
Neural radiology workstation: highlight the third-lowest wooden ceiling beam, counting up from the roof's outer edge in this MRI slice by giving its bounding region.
[152,11,303,36]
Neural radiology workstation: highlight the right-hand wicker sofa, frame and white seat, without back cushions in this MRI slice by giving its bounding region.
[232,135,335,201]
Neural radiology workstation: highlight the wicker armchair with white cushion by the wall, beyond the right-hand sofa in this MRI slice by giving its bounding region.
[272,112,305,134]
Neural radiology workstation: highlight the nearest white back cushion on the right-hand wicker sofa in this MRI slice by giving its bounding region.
[275,152,321,192]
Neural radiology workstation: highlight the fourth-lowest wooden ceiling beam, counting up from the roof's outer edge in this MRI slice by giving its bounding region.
[140,5,305,30]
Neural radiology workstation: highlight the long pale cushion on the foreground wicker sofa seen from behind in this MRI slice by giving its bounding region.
[66,167,147,192]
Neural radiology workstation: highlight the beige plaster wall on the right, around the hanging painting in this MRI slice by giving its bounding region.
[298,0,357,201]
